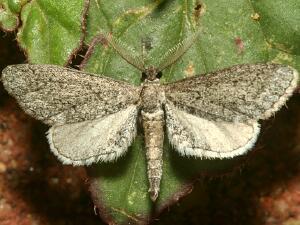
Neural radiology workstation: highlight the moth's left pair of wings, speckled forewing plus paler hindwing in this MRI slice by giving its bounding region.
[2,64,140,165]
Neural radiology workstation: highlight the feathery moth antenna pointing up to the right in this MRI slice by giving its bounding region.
[158,30,200,71]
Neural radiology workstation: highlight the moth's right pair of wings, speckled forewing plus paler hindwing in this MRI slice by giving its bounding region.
[164,64,298,158]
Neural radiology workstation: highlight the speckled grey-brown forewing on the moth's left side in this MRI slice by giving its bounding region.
[2,64,141,126]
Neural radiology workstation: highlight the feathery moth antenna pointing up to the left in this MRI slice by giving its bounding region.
[105,34,145,71]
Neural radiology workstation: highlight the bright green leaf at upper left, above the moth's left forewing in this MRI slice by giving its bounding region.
[18,0,85,65]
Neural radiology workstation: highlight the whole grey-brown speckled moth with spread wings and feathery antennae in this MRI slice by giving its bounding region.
[2,33,298,201]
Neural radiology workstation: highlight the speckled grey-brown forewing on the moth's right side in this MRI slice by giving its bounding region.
[164,64,298,122]
